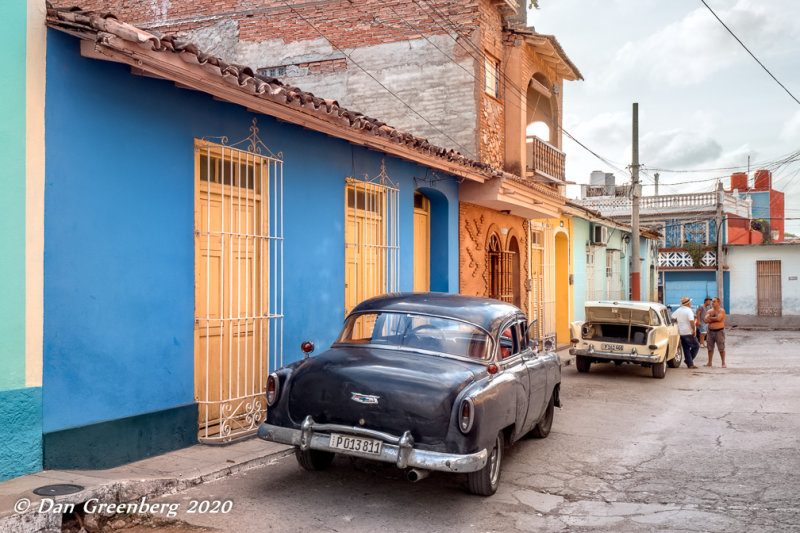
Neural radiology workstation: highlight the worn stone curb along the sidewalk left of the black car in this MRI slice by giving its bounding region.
[0,447,294,533]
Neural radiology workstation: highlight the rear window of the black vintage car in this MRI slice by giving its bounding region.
[337,313,492,359]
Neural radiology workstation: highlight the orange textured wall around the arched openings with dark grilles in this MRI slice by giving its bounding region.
[458,202,530,313]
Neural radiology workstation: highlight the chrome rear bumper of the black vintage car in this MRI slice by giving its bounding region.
[258,416,489,473]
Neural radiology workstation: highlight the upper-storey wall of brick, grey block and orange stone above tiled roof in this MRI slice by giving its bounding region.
[53,0,561,168]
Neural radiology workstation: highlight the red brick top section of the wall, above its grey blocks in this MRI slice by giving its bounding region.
[52,0,478,48]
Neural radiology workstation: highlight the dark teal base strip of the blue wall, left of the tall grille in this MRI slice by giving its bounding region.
[44,403,197,470]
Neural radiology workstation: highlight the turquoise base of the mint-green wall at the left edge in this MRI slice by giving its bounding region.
[0,387,42,481]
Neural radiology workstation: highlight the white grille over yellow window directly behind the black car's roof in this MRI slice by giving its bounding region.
[345,165,400,315]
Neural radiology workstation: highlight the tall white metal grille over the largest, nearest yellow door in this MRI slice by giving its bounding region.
[195,121,283,443]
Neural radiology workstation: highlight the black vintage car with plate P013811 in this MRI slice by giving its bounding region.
[258,293,561,495]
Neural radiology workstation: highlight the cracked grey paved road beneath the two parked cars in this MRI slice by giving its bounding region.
[147,331,800,532]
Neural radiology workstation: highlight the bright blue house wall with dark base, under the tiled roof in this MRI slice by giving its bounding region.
[43,30,458,468]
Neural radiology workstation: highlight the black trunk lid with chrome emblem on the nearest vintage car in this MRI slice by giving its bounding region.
[289,346,480,444]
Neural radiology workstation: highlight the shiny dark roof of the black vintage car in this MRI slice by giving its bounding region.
[352,292,524,333]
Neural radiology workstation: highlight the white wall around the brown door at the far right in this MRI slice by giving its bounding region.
[728,244,800,315]
